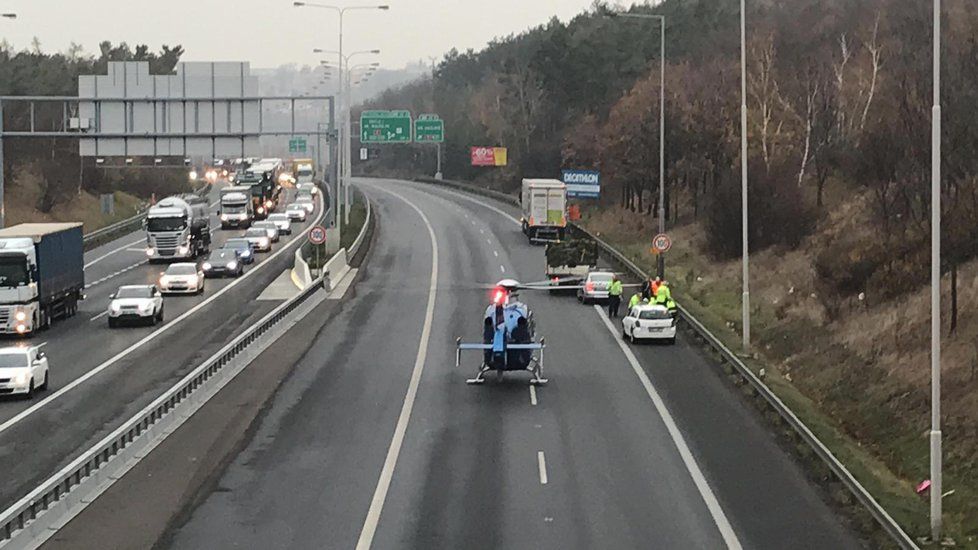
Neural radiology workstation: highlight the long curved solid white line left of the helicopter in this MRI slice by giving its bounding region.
[357,186,438,550]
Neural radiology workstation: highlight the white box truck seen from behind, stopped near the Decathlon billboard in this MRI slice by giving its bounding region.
[520,179,567,243]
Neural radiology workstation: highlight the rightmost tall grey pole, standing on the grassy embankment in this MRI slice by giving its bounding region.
[930,0,943,542]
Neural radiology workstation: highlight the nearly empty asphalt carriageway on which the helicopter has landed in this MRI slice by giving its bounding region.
[168,180,860,549]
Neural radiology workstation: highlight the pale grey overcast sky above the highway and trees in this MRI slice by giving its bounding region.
[0,0,612,68]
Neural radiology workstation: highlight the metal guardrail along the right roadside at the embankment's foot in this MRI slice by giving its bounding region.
[415,178,919,550]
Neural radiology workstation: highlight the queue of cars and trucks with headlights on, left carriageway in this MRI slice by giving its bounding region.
[0,159,319,398]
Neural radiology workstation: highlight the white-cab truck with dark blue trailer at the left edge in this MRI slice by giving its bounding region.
[0,223,85,336]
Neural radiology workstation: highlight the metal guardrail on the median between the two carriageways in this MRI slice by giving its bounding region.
[0,189,367,548]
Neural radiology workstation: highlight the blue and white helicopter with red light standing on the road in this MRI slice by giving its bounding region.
[455,279,547,384]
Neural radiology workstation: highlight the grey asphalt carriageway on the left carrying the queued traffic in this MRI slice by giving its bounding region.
[0,182,320,508]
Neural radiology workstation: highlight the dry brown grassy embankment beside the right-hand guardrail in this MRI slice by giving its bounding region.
[582,189,978,547]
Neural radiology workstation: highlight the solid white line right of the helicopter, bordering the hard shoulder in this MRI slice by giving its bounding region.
[594,305,741,550]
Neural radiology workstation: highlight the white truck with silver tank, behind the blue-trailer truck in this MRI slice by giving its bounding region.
[144,193,211,263]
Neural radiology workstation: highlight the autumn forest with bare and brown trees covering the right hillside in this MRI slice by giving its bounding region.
[364,0,978,324]
